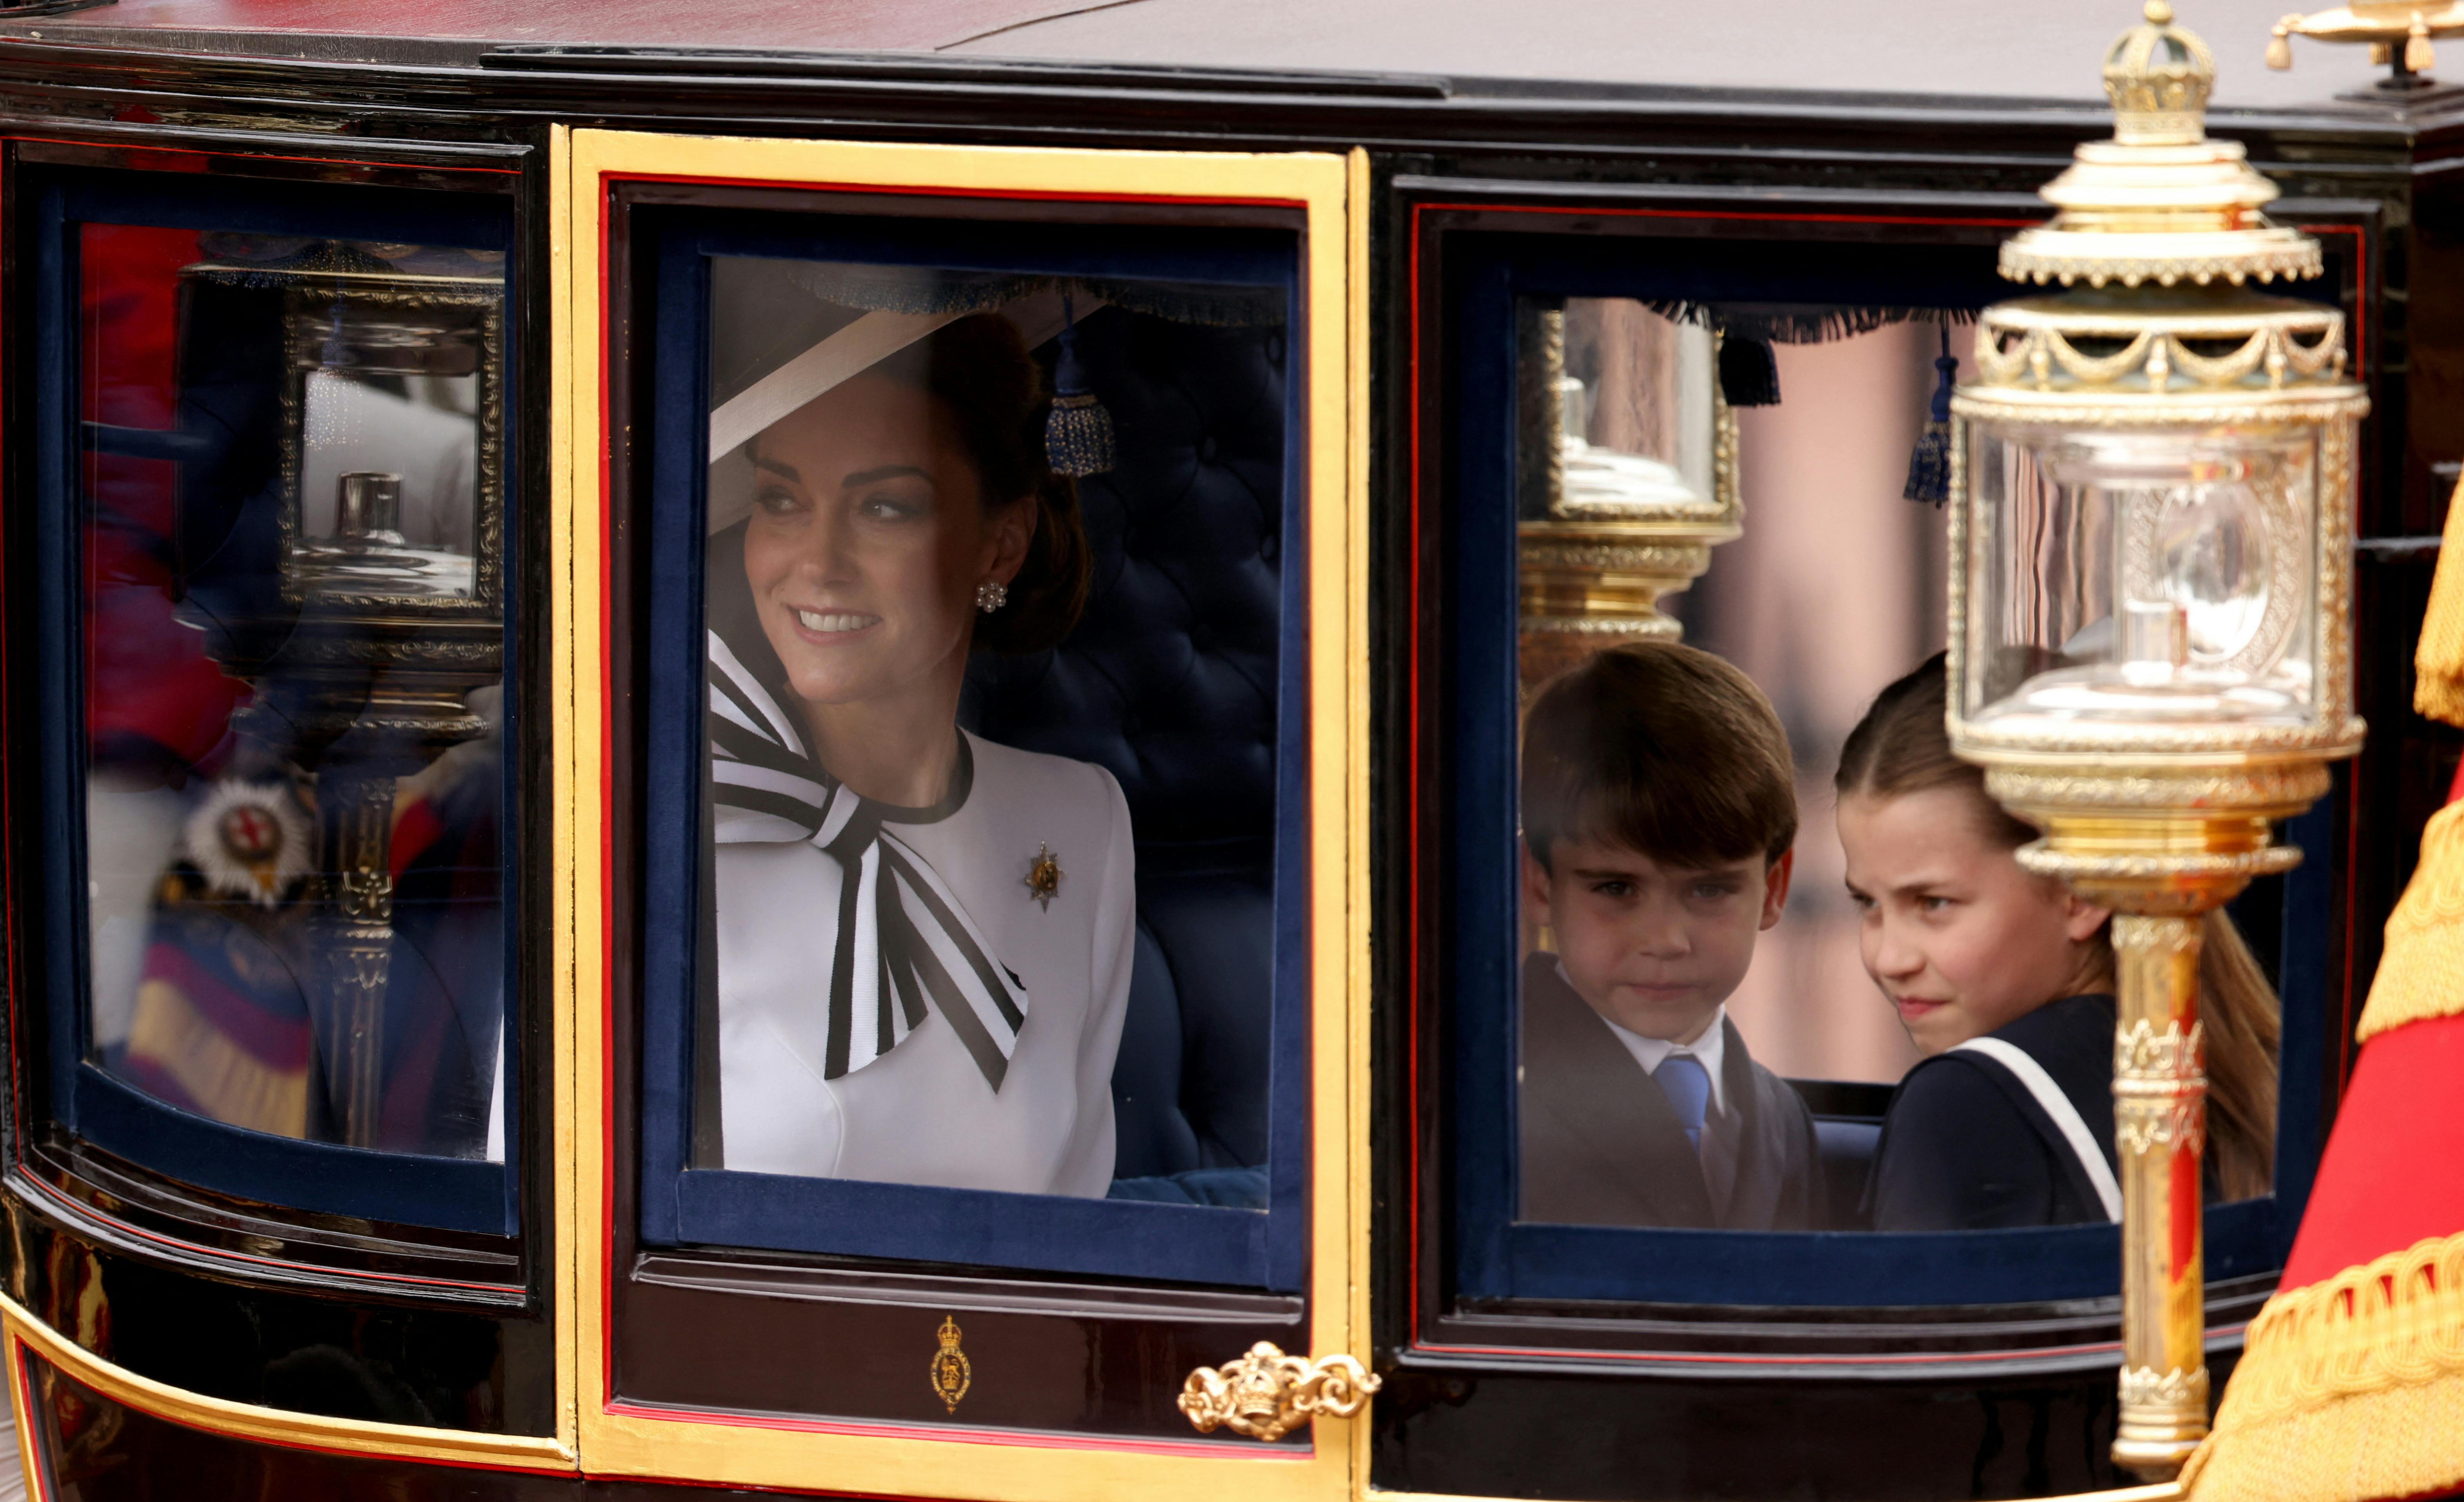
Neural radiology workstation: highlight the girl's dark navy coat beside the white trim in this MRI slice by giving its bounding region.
[1868,997,2119,1231]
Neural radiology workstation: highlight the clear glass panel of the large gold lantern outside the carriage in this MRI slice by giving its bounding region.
[1961,423,2321,734]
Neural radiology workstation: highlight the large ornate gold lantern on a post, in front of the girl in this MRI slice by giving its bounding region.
[1949,0,2368,1477]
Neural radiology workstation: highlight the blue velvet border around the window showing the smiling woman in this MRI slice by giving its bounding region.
[636,209,1308,1290]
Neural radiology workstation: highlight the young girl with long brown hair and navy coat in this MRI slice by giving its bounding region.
[1836,655,2279,1231]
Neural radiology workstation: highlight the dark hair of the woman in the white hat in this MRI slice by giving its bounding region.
[870,313,1094,652]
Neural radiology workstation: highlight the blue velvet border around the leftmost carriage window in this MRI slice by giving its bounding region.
[17,167,522,1236]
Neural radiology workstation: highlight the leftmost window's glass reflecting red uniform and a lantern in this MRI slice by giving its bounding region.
[79,224,505,1160]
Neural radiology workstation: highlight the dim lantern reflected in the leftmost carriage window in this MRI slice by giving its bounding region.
[180,241,505,1147]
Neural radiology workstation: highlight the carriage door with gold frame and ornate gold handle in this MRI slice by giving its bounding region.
[550,131,1375,1497]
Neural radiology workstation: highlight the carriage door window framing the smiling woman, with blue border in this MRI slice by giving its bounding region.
[645,226,1301,1288]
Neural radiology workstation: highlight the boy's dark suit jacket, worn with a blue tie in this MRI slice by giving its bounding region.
[1518,953,1823,1231]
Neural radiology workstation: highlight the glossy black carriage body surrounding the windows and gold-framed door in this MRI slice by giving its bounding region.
[0,0,2464,1500]
